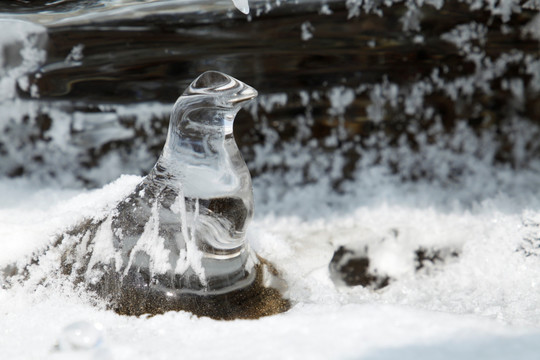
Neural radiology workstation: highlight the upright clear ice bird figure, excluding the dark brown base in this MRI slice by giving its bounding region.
[105,71,257,294]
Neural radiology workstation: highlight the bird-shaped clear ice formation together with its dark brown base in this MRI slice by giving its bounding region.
[58,71,287,318]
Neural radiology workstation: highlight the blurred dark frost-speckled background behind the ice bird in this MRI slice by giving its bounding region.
[0,0,540,198]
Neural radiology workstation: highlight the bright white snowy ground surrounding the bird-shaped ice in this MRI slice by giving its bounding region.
[0,165,540,359]
